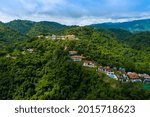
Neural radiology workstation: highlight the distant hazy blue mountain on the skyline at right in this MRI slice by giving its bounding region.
[90,19,150,32]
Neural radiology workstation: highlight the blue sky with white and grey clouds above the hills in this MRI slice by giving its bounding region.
[0,0,150,25]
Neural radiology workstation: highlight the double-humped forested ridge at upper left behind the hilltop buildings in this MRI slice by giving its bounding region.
[6,20,66,36]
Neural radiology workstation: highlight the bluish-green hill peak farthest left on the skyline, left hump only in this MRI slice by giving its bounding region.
[6,20,36,34]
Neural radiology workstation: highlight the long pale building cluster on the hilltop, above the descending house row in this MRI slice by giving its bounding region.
[38,34,79,40]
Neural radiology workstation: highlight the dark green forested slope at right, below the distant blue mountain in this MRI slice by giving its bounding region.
[96,29,150,51]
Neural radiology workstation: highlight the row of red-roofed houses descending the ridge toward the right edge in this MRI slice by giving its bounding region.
[69,51,150,83]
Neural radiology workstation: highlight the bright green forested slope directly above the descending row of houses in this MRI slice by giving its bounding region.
[66,27,150,73]
